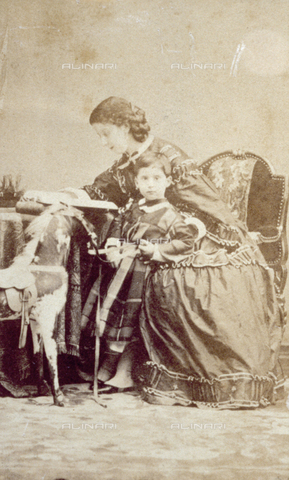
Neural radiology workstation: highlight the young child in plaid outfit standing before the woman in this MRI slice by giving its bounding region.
[98,152,206,388]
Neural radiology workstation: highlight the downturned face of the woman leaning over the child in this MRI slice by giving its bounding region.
[92,123,130,155]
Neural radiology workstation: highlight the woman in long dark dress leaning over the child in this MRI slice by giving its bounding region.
[78,97,281,408]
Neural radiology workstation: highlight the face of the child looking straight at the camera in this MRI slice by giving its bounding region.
[135,166,171,200]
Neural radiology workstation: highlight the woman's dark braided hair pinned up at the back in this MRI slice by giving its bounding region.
[89,97,150,142]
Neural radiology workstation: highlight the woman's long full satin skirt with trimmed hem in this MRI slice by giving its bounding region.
[140,248,281,408]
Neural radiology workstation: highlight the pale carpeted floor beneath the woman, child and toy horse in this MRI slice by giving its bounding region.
[0,384,289,480]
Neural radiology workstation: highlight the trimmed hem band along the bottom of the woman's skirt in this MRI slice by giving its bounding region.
[142,362,277,409]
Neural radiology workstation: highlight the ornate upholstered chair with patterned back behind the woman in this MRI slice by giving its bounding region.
[201,151,288,323]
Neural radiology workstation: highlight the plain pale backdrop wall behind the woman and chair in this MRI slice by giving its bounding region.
[0,0,289,342]
